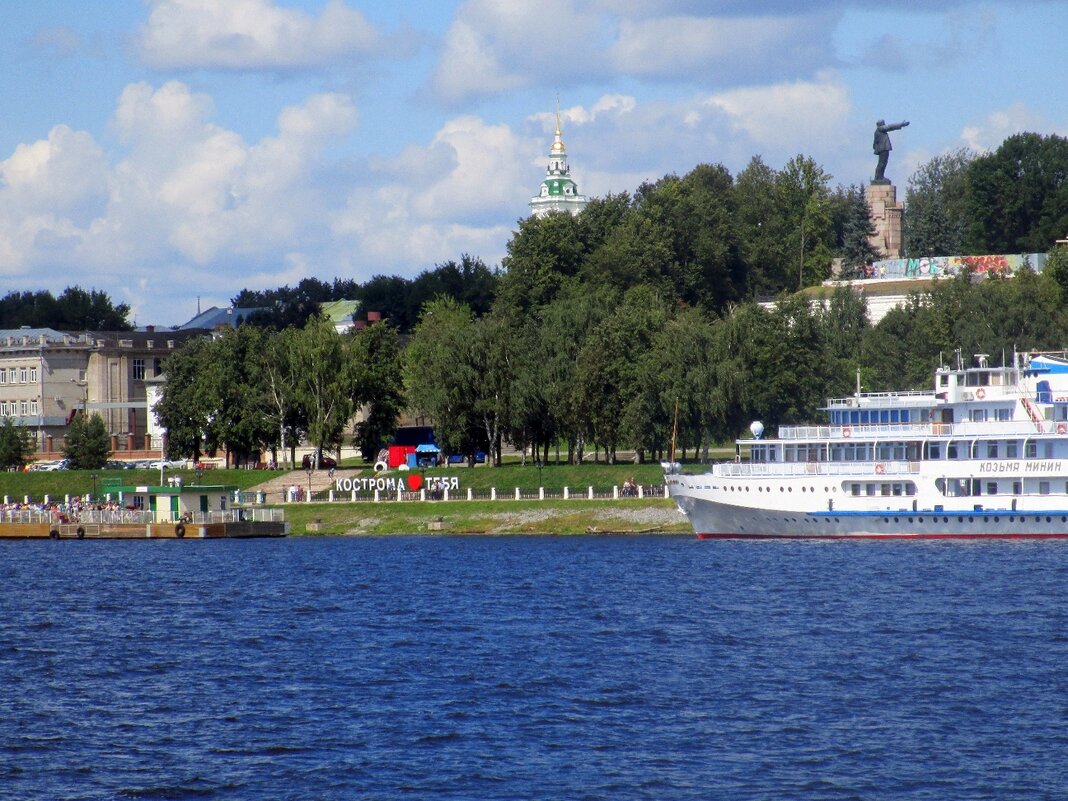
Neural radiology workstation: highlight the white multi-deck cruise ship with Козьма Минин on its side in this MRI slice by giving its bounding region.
[665,354,1068,539]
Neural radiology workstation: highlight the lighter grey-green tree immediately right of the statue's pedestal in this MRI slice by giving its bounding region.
[905,147,975,257]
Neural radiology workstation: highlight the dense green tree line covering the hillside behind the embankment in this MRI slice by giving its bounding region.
[8,134,1068,469]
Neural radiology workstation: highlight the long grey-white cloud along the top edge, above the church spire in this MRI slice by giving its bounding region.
[433,0,837,104]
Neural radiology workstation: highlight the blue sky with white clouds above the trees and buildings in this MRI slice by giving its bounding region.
[0,0,1068,326]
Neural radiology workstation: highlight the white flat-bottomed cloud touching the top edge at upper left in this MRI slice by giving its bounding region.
[138,0,383,69]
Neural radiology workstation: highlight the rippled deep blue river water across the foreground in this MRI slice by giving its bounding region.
[0,537,1068,801]
